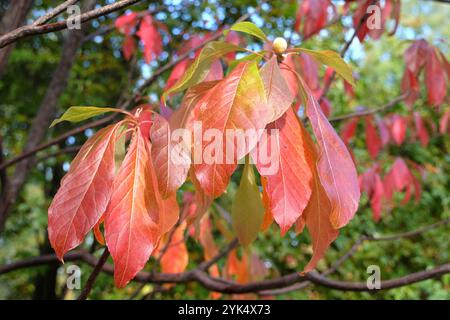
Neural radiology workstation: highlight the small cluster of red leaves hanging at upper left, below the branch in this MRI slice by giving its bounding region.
[115,12,164,63]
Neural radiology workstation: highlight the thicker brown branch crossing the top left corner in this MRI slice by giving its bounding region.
[0,0,141,48]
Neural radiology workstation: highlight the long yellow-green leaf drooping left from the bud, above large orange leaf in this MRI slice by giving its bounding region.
[164,41,245,97]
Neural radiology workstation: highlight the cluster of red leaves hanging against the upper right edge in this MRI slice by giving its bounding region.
[402,39,450,106]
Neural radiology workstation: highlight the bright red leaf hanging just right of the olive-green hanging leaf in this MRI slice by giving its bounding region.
[252,109,312,234]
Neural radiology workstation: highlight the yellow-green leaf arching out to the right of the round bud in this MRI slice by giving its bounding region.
[291,48,355,86]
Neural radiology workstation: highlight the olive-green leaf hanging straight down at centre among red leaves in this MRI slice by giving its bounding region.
[231,156,264,246]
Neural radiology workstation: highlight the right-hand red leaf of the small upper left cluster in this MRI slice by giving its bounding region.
[136,15,162,63]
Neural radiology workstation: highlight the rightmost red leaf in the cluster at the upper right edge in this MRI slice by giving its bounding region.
[425,46,447,105]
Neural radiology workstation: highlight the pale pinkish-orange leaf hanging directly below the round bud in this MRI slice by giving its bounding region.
[260,56,294,122]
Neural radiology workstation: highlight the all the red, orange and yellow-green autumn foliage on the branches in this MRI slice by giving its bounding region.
[44,0,450,287]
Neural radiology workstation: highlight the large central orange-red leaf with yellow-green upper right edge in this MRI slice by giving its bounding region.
[194,62,268,197]
